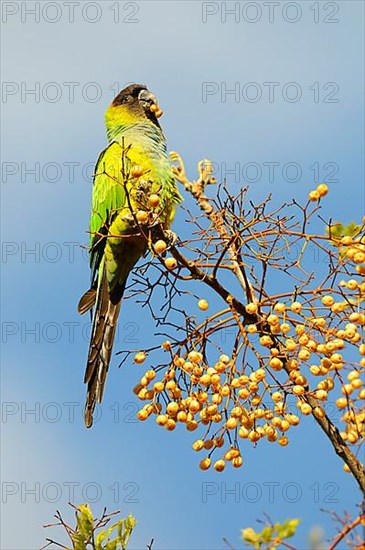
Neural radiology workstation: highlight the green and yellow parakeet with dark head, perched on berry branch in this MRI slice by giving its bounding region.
[78,84,182,428]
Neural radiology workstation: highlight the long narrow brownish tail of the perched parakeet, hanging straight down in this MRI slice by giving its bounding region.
[84,268,121,428]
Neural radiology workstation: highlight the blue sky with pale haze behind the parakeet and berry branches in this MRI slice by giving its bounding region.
[1,0,364,550]
